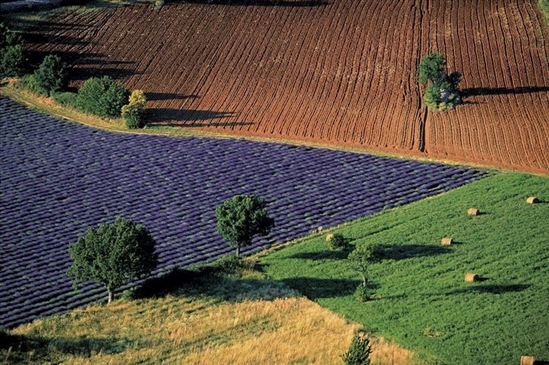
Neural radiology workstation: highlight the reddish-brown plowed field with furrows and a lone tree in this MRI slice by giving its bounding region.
[21,0,549,174]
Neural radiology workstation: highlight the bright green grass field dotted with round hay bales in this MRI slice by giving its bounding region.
[262,174,549,365]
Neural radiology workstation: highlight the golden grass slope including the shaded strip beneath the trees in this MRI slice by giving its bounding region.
[0,269,411,365]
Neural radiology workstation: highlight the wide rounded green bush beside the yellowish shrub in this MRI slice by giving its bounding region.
[75,76,130,118]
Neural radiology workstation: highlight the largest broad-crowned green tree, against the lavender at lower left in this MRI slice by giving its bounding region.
[67,217,158,303]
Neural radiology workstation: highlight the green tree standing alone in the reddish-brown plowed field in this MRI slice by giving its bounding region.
[418,53,461,110]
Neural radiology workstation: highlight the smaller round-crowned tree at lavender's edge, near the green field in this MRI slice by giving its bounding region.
[215,195,274,257]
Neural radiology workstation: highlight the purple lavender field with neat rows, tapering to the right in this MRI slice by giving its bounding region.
[0,98,489,327]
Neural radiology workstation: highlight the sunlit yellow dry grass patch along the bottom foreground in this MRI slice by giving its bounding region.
[8,290,412,365]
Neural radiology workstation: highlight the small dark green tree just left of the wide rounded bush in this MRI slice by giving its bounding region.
[32,54,68,96]
